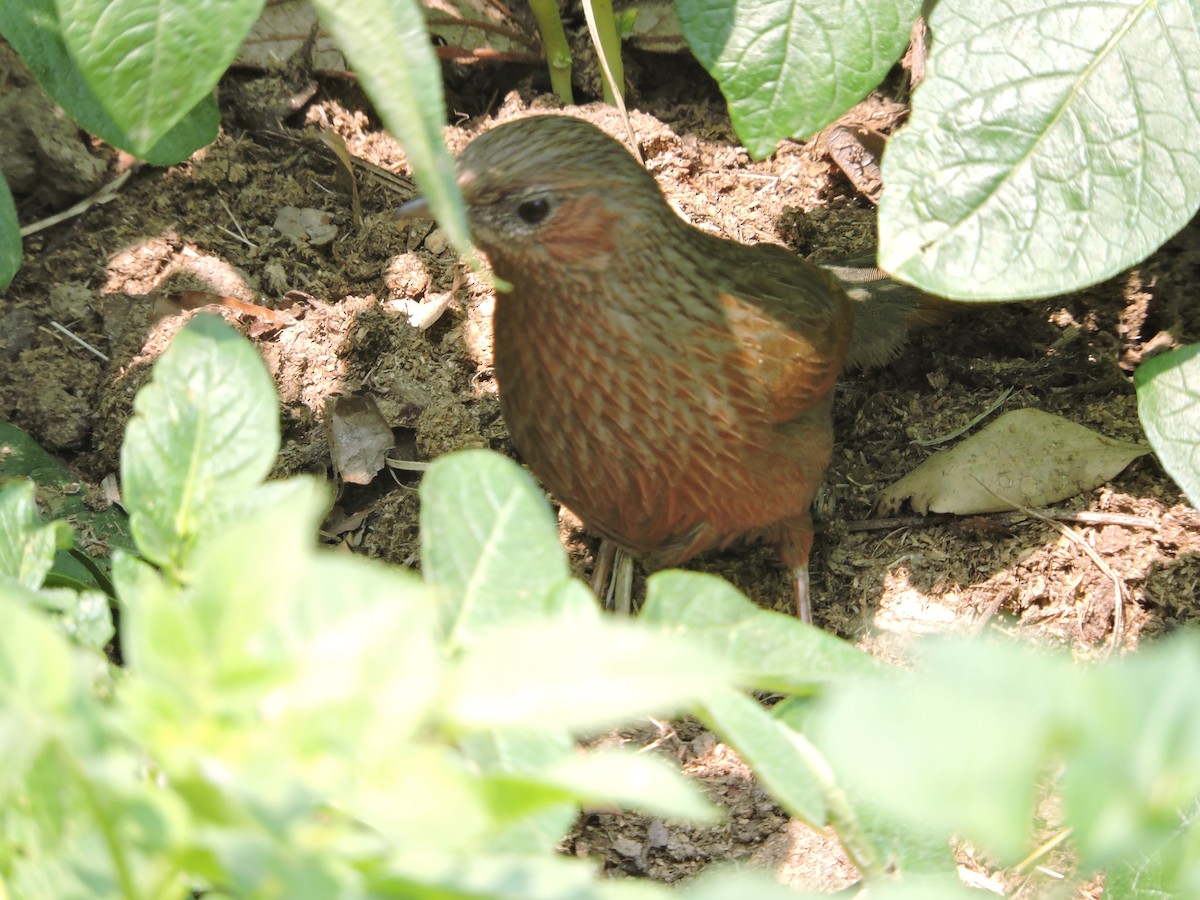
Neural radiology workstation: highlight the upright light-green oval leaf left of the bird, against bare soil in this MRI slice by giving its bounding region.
[121,316,280,576]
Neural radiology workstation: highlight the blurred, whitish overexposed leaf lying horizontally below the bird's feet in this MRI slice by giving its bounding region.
[445,619,731,730]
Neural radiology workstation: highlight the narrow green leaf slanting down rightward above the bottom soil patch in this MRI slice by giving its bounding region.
[696,689,832,828]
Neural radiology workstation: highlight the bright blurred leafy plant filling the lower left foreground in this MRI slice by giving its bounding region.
[0,316,816,898]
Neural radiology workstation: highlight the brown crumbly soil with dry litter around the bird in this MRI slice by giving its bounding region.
[0,33,1200,896]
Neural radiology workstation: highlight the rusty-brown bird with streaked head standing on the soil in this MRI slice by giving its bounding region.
[397,114,923,623]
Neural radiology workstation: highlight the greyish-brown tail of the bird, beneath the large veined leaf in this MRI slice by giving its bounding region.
[821,257,965,368]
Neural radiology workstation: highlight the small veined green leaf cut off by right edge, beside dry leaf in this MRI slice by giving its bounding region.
[1133,343,1200,506]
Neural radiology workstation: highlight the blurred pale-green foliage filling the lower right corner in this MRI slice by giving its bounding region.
[814,634,1200,898]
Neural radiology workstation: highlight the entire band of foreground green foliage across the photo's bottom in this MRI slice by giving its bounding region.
[7,301,1200,900]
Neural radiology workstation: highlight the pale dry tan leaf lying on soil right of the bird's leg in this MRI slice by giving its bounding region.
[880,409,1150,515]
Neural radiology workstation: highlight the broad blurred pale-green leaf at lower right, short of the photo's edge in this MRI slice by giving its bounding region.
[809,641,1070,862]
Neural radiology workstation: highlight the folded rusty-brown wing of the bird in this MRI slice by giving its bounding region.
[716,245,853,422]
